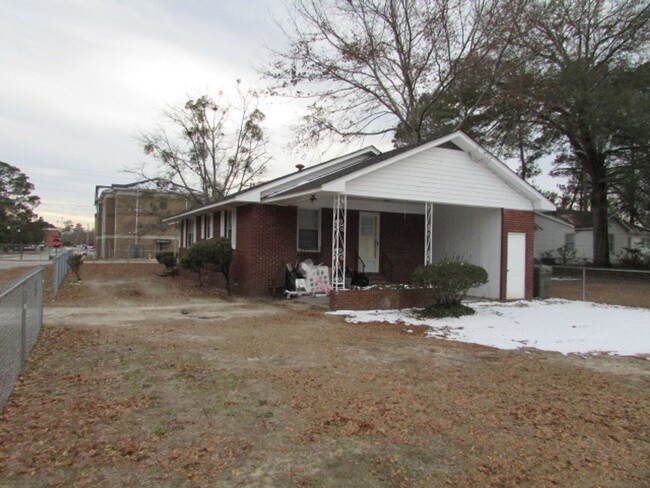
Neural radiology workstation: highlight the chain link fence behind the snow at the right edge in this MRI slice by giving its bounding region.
[550,266,650,308]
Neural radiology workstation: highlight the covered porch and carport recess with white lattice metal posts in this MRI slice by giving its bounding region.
[264,191,502,298]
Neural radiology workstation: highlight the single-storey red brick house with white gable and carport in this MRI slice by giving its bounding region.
[165,132,554,298]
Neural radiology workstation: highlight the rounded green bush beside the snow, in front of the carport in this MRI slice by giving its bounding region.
[413,257,488,317]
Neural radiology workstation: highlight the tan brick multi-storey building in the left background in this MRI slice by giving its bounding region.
[95,180,189,259]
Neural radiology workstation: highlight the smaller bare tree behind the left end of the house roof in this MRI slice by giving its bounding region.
[133,82,270,203]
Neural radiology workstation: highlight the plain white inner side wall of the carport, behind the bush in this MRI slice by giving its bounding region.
[433,205,501,298]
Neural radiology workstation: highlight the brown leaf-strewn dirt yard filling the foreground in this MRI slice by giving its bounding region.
[0,264,650,487]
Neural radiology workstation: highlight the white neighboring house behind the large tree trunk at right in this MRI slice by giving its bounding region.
[535,210,650,263]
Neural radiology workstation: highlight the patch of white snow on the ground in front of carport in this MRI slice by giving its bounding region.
[331,299,650,356]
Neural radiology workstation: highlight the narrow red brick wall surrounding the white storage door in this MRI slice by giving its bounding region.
[501,209,535,300]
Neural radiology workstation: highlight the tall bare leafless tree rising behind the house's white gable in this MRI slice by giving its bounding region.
[265,0,518,143]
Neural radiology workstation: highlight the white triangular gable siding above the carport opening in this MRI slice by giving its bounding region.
[345,147,533,210]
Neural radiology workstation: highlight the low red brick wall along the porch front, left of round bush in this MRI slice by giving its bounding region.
[330,288,433,310]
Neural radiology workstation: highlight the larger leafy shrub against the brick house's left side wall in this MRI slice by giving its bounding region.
[180,237,233,294]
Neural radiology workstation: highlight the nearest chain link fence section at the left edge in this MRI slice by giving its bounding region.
[0,267,44,411]
